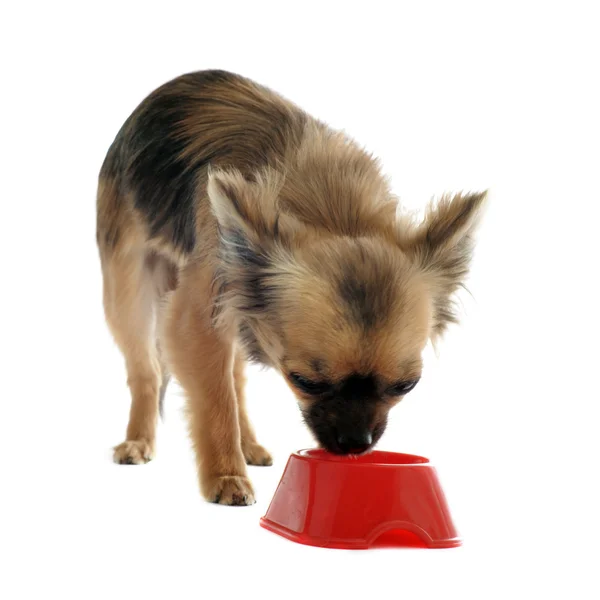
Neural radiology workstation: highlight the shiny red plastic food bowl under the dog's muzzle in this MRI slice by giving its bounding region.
[260,450,461,549]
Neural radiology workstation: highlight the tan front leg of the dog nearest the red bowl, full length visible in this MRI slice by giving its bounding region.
[161,266,254,505]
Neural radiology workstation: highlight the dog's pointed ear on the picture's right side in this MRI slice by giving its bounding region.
[400,192,487,338]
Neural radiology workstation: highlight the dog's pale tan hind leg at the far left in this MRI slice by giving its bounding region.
[102,249,166,464]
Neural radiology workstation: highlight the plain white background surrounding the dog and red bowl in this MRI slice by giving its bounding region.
[0,1,600,600]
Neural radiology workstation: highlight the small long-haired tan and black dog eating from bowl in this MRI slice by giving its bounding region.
[97,71,485,504]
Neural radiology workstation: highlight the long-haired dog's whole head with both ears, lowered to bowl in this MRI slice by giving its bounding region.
[208,166,485,454]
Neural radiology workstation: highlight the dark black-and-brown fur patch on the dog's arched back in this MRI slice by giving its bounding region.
[100,70,306,253]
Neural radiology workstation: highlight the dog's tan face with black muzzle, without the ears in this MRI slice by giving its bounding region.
[277,239,432,454]
